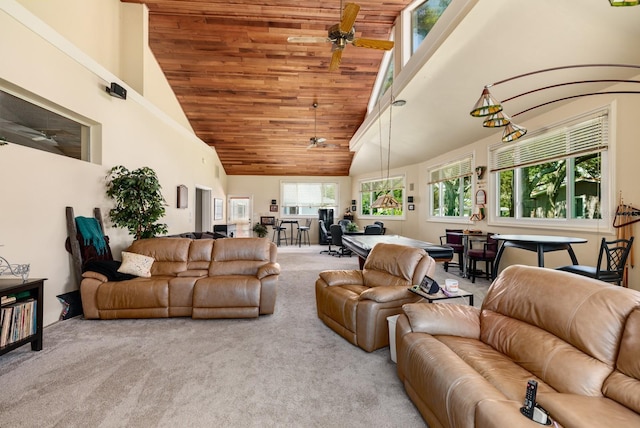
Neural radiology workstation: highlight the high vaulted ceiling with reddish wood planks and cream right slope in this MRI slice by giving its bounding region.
[122,0,640,176]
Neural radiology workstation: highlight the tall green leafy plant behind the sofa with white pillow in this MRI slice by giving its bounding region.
[106,165,167,239]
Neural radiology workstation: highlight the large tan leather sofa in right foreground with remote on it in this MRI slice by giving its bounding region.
[396,266,640,428]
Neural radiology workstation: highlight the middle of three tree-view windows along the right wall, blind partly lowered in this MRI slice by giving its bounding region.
[429,155,473,218]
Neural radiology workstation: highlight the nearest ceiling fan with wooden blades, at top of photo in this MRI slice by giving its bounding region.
[287,2,393,71]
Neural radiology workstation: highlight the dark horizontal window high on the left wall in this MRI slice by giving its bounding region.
[0,90,89,161]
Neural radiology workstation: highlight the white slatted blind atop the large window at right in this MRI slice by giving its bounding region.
[489,111,609,172]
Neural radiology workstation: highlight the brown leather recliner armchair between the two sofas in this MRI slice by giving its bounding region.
[316,243,436,352]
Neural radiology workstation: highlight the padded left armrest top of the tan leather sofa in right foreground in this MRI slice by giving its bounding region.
[402,303,480,339]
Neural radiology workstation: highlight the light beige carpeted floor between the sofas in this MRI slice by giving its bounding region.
[0,246,489,427]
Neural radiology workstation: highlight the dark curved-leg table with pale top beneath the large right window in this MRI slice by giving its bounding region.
[492,234,587,279]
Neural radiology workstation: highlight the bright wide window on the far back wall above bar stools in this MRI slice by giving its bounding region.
[280,182,338,216]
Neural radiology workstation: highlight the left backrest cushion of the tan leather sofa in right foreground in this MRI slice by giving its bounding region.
[480,266,640,396]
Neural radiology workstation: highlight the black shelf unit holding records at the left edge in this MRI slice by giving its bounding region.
[0,278,46,355]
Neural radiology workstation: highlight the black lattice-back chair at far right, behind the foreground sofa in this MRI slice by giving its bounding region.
[557,236,633,285]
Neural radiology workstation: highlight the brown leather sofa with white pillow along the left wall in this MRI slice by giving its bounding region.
[80,238,280,319]
